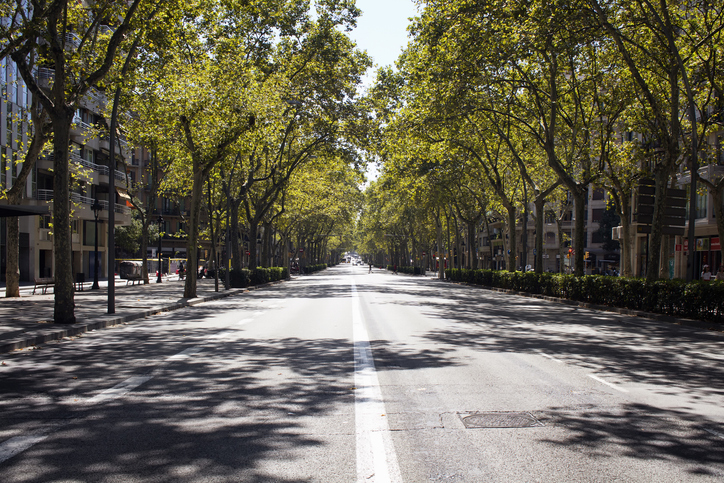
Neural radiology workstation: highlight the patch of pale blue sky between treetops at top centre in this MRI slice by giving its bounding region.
[350,0,417,82]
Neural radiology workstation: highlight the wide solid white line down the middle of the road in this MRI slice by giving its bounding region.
[352,280,402,483]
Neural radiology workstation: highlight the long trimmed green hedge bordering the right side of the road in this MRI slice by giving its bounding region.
[445,268,724,322]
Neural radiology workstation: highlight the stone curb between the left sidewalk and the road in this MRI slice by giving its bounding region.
[0,283,252,353]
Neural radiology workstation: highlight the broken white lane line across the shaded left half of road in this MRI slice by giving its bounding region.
[0,347,202,464]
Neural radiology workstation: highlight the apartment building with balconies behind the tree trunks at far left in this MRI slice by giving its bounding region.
[0,59,131,281]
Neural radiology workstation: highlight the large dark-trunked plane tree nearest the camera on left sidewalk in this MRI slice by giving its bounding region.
[0,0,160,324]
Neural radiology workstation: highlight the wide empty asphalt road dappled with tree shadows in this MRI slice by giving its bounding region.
[0,266,724,483]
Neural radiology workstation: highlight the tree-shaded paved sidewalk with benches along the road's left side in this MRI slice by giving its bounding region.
[0,276,247,353]
